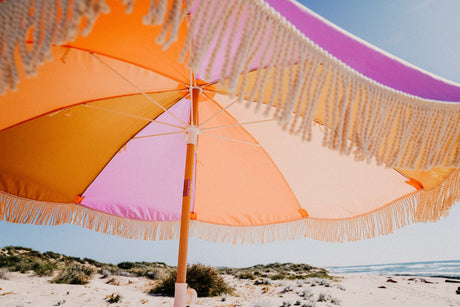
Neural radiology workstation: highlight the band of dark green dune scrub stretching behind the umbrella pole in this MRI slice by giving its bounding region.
[0,246,330,302]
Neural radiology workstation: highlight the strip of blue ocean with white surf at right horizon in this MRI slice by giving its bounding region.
[326,260,460,279]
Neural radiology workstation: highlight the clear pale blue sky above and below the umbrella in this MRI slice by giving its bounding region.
[0,0,460,267]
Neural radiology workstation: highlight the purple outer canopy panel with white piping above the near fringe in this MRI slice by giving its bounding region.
[266,0,460,102]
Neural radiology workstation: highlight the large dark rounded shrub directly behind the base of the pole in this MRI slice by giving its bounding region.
[150,264,233,297]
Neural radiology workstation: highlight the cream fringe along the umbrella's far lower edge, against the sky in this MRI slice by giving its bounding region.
[0,170,460,244]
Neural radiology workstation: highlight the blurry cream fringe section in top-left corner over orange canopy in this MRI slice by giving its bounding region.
[0,0,109,95]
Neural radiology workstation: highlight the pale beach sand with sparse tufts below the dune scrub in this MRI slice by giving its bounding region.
[0,272,460,307]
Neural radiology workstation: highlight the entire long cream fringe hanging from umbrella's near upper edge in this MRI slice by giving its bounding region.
[0,0,460,170]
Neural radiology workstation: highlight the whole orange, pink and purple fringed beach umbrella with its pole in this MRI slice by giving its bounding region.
[0,0,460,306]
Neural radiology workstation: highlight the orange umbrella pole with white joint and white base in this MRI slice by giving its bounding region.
[174,88,200,307]
